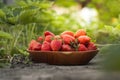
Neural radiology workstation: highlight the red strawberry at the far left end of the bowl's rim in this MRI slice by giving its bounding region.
[29,40,42,51]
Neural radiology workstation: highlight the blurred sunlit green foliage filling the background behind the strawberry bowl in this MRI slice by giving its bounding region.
[0,0,120,69]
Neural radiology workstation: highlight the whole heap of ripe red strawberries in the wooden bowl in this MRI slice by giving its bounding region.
[28,29,97,51]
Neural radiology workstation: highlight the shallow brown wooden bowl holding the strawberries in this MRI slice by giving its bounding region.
[28,50,98,65]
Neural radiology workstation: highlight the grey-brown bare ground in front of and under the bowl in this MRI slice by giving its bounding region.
[0,54,120,80]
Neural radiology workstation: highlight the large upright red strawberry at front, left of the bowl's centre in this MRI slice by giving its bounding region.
[50,39,62,51]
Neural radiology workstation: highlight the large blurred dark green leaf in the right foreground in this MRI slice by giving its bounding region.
[100,44,120,71]
